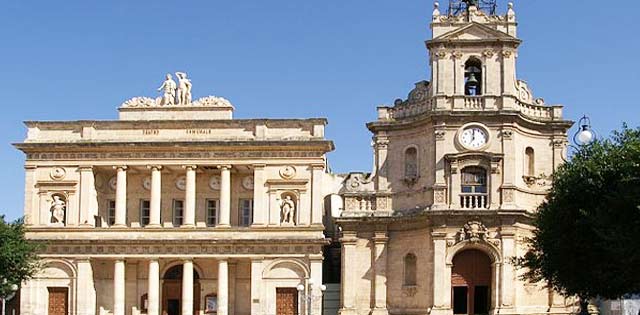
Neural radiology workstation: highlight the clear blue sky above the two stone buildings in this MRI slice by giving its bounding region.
[0,0,640,219]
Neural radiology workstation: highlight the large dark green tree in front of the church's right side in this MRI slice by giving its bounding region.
[516,126,640,312]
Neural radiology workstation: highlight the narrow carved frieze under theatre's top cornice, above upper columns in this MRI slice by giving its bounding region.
[27,151,324,161]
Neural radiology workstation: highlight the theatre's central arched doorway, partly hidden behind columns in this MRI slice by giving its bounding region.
[162,265,200,315]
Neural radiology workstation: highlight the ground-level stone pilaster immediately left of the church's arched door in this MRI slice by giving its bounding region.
[431,232,451,314]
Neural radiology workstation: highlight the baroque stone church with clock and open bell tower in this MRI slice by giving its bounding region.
[337,3,573,315]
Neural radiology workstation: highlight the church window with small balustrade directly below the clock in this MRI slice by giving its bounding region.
[460,166,489,209]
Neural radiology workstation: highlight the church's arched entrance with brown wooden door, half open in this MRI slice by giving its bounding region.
[451,249,491,315]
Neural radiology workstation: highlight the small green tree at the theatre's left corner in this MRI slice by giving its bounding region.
[0,215,40,297]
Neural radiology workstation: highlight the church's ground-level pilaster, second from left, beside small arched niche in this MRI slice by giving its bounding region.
[371,232,389,315]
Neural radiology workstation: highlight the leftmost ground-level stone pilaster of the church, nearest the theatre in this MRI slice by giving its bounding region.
[339,232,358,315]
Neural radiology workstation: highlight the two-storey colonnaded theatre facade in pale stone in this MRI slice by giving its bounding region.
[16,76,333,315]
